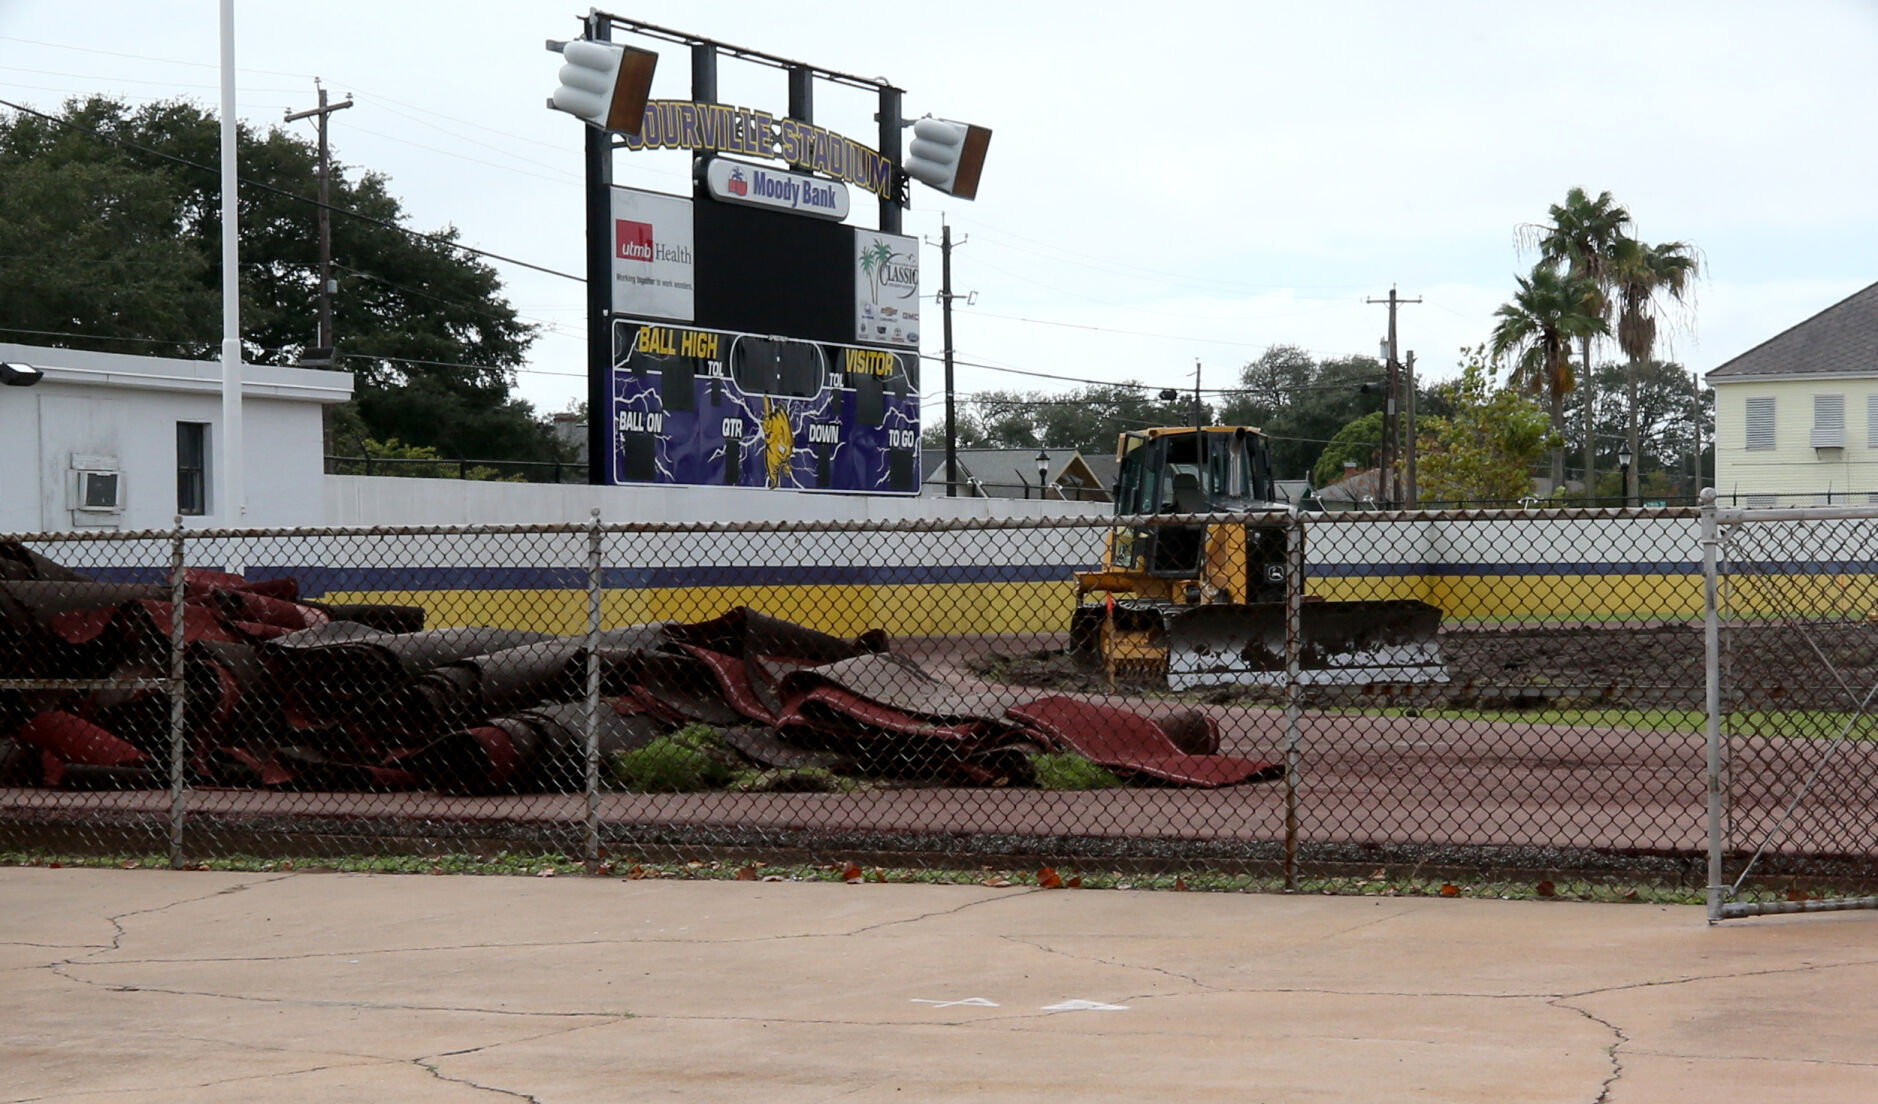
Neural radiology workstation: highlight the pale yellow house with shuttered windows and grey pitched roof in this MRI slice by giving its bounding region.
[1705,284,1878,505]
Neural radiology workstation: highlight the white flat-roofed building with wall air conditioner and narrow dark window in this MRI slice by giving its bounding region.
[0,342,353,533]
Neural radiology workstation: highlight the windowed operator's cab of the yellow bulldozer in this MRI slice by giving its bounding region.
[1116,426,1279,578]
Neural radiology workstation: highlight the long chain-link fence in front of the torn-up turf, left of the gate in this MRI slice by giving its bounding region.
[0,509,1832,896]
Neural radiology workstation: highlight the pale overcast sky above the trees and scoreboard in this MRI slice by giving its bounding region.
[0,0,1878,421]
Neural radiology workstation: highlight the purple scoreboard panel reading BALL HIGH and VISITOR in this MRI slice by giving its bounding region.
[607,319,920,494]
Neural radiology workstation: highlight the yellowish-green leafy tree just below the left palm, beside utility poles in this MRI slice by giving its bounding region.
[1418,345,1555,501]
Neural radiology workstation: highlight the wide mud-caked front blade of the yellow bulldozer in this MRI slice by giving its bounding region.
[1164,599,1448,691]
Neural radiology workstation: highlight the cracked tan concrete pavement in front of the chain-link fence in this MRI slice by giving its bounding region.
[11,867,1878,1104]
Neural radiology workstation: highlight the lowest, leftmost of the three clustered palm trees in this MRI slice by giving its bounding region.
[1487,261,1611,490]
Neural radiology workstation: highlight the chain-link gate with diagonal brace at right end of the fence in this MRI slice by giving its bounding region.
[1705,505,1878,922]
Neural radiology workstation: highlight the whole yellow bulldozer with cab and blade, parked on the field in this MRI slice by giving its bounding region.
[1070,426,1448,691]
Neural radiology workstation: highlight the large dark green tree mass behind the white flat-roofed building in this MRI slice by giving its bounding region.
[0,96,562,469]
